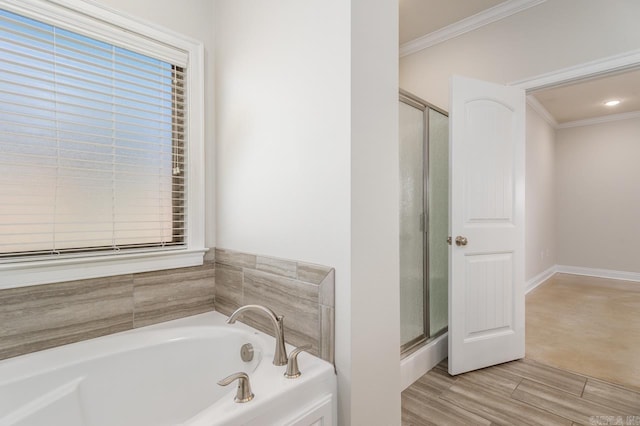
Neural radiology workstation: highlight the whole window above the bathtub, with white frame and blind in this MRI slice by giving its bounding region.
[0,0,204,287]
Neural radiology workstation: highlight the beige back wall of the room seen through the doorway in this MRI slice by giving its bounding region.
[556,118,640,273]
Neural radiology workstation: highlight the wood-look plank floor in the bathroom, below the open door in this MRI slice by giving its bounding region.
[402,359,640,426]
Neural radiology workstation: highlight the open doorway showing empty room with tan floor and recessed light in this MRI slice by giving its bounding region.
[526,66,640,389]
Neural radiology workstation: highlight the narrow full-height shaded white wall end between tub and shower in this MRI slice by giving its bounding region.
[350,0,400,426]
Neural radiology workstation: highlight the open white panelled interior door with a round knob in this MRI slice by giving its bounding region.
[449,76,525,374]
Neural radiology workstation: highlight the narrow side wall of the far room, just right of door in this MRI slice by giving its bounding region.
[525,106,557,280]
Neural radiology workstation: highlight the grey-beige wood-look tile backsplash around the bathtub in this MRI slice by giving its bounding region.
[0,249,335,362]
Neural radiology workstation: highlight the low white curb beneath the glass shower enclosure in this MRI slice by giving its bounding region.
[400,333,449,390]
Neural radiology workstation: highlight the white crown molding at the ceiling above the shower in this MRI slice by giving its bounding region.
[400,0,546,57]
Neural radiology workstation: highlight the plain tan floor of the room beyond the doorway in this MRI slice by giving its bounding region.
[526,274,640,391]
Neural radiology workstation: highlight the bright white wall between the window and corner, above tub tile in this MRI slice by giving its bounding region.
[215,0,351,276]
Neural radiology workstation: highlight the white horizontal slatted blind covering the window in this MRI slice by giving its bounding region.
[0,9,187,261]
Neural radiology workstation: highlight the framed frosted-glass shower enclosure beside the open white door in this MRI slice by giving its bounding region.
[399,90,449,355]
